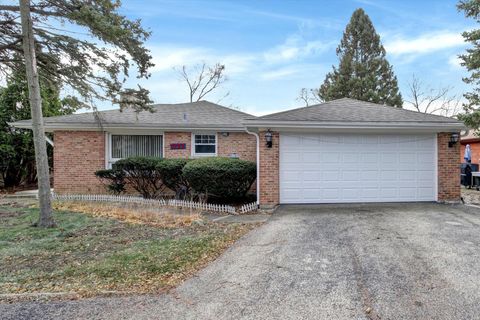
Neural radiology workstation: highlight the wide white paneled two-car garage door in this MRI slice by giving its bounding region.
[280,133,436,203]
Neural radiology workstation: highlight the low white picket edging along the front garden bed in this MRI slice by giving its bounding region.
[52,193,258,214]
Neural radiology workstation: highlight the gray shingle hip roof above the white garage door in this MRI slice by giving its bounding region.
[256,98,461,124]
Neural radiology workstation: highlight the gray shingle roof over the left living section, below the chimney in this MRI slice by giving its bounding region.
[12,101,255,129]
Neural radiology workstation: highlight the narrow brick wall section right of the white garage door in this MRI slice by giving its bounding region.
[437,132,463,202]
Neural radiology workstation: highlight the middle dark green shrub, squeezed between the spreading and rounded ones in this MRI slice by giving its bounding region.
[155,159,190,199]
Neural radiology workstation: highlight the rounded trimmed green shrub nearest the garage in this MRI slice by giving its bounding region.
[183,158,257,199]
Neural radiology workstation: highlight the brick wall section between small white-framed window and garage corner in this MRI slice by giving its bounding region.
[217,132,257,162]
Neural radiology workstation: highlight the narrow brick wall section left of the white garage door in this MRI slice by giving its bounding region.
[259,132,280,208]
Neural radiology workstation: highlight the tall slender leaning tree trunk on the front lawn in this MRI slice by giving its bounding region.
[20,0,55,227]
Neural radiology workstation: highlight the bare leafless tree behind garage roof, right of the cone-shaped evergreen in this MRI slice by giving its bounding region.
[405,75,462,117]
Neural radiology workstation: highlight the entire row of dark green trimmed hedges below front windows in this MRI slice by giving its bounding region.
[95,157,257,200]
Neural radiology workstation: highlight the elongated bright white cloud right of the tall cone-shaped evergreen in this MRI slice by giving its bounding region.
[385,32,465,55]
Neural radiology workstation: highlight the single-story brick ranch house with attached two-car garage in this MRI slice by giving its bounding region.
[11,98,464,208]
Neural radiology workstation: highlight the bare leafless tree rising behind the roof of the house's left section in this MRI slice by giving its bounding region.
[175,63,228,102]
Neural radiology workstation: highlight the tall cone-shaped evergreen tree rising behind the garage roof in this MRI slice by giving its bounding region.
[318,9,403,108]
